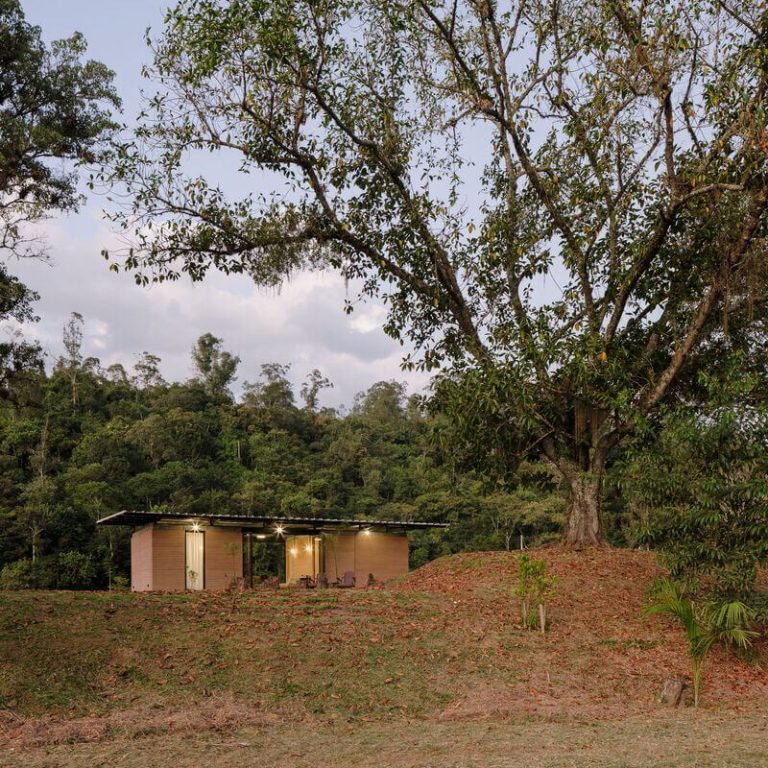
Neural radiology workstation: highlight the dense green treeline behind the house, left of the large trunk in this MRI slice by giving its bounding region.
[0,315,565,587]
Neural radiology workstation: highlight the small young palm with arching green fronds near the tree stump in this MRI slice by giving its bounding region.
[646,579,757,707]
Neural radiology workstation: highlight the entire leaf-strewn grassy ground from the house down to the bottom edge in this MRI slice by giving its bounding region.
[0,549,768,768]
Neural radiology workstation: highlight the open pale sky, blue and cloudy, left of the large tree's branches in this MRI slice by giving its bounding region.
[10,0,428,406]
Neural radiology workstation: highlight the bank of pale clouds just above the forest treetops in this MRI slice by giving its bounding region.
[10,216,428,406]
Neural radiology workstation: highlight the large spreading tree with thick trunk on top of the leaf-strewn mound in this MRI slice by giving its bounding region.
[108,0,768,544]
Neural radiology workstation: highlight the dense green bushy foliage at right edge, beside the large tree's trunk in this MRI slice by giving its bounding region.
[617,369,768,600]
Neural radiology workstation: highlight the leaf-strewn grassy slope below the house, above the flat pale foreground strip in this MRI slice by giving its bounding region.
[0,548,768,765]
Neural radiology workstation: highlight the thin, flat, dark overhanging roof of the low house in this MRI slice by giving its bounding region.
[96,510,448,533]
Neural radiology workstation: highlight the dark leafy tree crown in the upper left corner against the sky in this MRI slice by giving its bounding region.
[0,0,120,256]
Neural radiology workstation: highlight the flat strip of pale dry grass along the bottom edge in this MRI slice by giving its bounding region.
[0,711,768,768]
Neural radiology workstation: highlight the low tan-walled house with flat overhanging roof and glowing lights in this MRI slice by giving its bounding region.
[98,511,446,592]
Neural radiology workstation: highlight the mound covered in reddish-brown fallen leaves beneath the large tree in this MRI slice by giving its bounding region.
[402,547,768,720]
